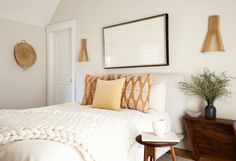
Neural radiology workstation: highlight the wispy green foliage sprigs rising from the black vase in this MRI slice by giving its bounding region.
[180,68,231,104]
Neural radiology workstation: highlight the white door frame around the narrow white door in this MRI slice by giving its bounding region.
[46,19,77,105]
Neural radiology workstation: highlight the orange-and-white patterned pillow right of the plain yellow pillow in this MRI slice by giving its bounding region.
[121,74,152,112]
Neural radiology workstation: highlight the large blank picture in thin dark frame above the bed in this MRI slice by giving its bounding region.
[103,14,169,69]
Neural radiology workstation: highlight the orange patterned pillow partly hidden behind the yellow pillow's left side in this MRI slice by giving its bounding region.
[82,74,121,105]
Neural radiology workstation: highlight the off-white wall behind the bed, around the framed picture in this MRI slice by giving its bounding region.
[51,0,236,119]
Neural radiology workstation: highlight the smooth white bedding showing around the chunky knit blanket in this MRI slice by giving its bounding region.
[0,103,170,161]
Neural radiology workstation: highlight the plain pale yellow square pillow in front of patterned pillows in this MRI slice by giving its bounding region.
[92,78,126,111]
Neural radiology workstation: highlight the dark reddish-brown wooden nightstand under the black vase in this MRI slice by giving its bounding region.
[184,115,236,161]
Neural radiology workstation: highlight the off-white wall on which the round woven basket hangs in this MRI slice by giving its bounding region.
[0,19,46,109]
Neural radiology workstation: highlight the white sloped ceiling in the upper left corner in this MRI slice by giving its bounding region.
[0,0,60,26]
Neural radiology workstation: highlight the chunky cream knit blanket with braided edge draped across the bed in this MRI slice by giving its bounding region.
[0,109,136,161]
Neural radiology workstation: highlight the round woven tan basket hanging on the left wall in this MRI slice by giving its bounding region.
[14,40,36,70]
